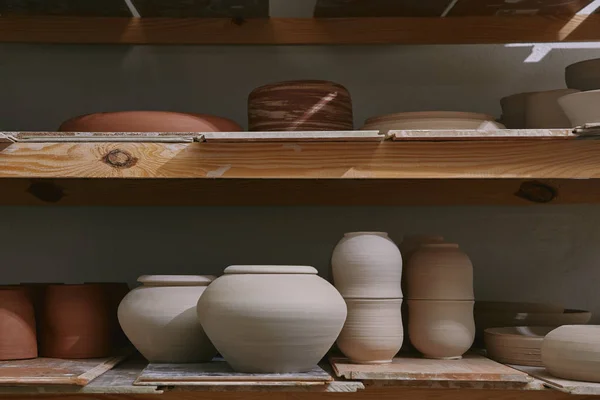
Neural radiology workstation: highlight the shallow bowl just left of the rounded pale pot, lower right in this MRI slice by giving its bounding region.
[484,326,554,367]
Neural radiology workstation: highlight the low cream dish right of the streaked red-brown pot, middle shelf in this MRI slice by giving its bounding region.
[362,111,504,132]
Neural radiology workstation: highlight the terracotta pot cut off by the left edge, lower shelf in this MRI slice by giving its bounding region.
[0,286,38,361]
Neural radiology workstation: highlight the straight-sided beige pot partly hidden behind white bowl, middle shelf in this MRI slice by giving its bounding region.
[525,89,578,129]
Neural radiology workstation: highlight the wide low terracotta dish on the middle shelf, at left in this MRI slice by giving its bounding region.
[58,111,242,132]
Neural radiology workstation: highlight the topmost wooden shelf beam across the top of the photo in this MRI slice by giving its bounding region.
[0,15,600,45]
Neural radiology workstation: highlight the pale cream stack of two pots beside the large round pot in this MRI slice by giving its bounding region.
[331,232,404,364]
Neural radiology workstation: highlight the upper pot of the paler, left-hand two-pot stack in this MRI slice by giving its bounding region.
[331,232,403,299]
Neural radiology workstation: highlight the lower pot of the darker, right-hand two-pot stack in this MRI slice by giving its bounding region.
[408,300,475,359]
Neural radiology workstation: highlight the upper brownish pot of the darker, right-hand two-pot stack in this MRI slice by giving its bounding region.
[406,243,475,300]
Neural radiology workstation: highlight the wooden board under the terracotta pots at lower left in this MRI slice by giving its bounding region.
[0,350,131,386]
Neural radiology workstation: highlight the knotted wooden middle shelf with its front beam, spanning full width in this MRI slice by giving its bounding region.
[0,131,600,205]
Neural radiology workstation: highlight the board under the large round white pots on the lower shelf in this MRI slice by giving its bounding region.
[134,360,333,386]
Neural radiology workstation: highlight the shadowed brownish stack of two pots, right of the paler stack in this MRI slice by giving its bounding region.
[406,241,475,359]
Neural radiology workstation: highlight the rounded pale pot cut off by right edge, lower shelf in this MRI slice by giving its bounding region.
[542,325,600,383]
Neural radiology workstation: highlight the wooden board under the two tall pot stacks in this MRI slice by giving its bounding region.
[330,354,532,385]
